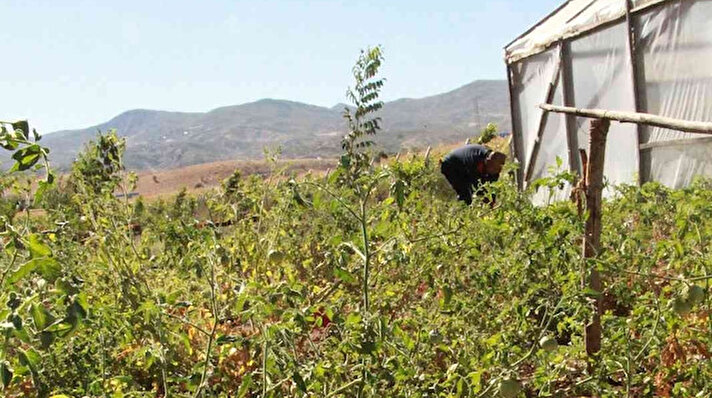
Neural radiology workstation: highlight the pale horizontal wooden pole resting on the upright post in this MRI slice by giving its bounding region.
[539,104,712,135]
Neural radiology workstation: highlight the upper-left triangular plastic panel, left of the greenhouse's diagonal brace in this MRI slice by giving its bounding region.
[512,49,559,182]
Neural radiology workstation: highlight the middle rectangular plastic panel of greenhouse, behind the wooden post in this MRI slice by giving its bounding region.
[571,23,638,190]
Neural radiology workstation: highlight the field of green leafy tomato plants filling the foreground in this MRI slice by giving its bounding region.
[0,125,712,397]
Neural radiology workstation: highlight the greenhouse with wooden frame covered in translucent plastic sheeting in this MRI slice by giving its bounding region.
[505,0,712,193]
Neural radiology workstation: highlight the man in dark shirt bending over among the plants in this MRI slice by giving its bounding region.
[440,145,507,205]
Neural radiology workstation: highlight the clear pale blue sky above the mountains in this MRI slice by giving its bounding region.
[0,0,562,133]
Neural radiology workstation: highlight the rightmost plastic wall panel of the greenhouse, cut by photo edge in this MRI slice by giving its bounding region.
[637,1,712,188]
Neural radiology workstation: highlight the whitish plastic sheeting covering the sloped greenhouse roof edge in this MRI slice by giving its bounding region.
[505,0,660,63]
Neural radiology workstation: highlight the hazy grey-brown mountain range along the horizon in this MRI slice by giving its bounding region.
[34,81,510,170]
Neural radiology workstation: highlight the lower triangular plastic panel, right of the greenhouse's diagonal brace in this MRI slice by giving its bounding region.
[531,79,571,205]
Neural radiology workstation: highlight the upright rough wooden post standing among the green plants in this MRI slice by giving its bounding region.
[581,119,611,356]
